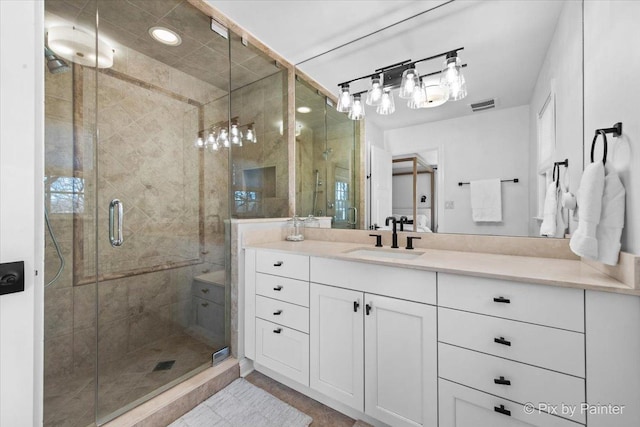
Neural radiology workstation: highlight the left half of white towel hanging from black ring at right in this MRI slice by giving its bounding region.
[569,162,604,259]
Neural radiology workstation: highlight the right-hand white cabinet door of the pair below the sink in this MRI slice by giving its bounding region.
[364,294,437,427]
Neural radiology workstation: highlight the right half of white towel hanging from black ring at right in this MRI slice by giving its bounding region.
[596,167,625,265]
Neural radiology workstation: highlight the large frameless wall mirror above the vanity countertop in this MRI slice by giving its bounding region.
[297,0,584,237]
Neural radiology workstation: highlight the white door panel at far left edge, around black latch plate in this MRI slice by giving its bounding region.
[0,0,44,427]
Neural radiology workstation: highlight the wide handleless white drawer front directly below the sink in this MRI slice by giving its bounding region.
[310,257,436,305]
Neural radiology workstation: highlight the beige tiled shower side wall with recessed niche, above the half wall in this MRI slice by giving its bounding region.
[231,72,289,218]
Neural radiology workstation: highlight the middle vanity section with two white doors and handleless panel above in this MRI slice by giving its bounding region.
[310,257,437,426]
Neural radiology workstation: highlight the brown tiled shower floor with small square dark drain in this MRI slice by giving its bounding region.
[44,333,218,427]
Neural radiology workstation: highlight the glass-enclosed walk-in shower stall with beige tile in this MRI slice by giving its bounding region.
[43,0,287,427]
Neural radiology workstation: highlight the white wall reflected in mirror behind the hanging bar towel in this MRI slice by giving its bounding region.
[384,105,529,236]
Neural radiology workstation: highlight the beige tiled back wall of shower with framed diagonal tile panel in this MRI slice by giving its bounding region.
[44,48,228,378]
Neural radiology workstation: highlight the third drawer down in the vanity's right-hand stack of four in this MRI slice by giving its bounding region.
[438,344,585,423]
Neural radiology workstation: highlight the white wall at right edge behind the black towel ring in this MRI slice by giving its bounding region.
[584,1,640,254]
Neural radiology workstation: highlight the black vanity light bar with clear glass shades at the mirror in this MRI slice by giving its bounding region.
[336,47,467,120]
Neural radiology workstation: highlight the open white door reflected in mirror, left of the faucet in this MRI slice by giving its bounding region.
[371,146,393,226]
